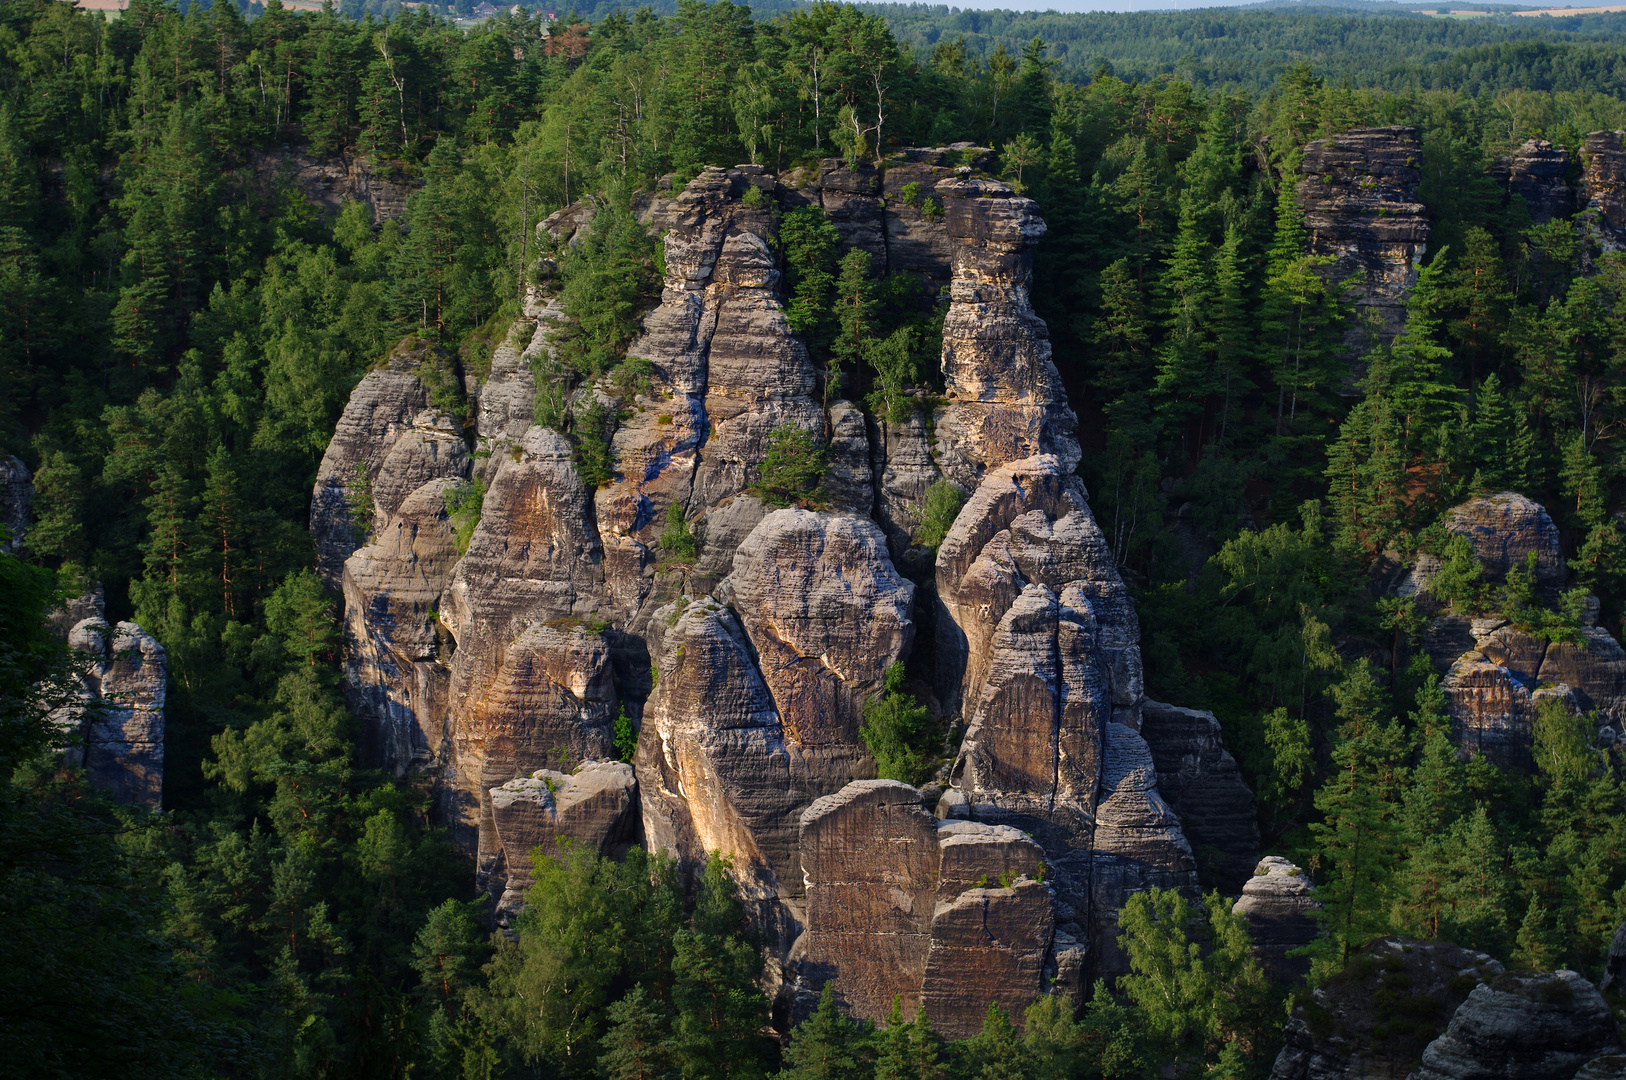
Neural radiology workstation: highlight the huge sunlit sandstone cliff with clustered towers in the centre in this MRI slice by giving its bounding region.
[312,160,1257,1034]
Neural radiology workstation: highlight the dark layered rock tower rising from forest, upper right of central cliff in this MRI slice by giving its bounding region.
[1298,127,1428,348]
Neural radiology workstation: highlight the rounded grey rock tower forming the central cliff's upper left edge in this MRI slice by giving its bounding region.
[311,338,434,590]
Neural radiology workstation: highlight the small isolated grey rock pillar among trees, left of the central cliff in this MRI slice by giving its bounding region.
[68,618,169,808]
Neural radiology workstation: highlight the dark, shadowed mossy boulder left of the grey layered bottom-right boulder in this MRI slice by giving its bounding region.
[1270,937,1502,1080]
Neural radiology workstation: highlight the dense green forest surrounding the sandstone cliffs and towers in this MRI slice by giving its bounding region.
[0,0,1626,1080]
